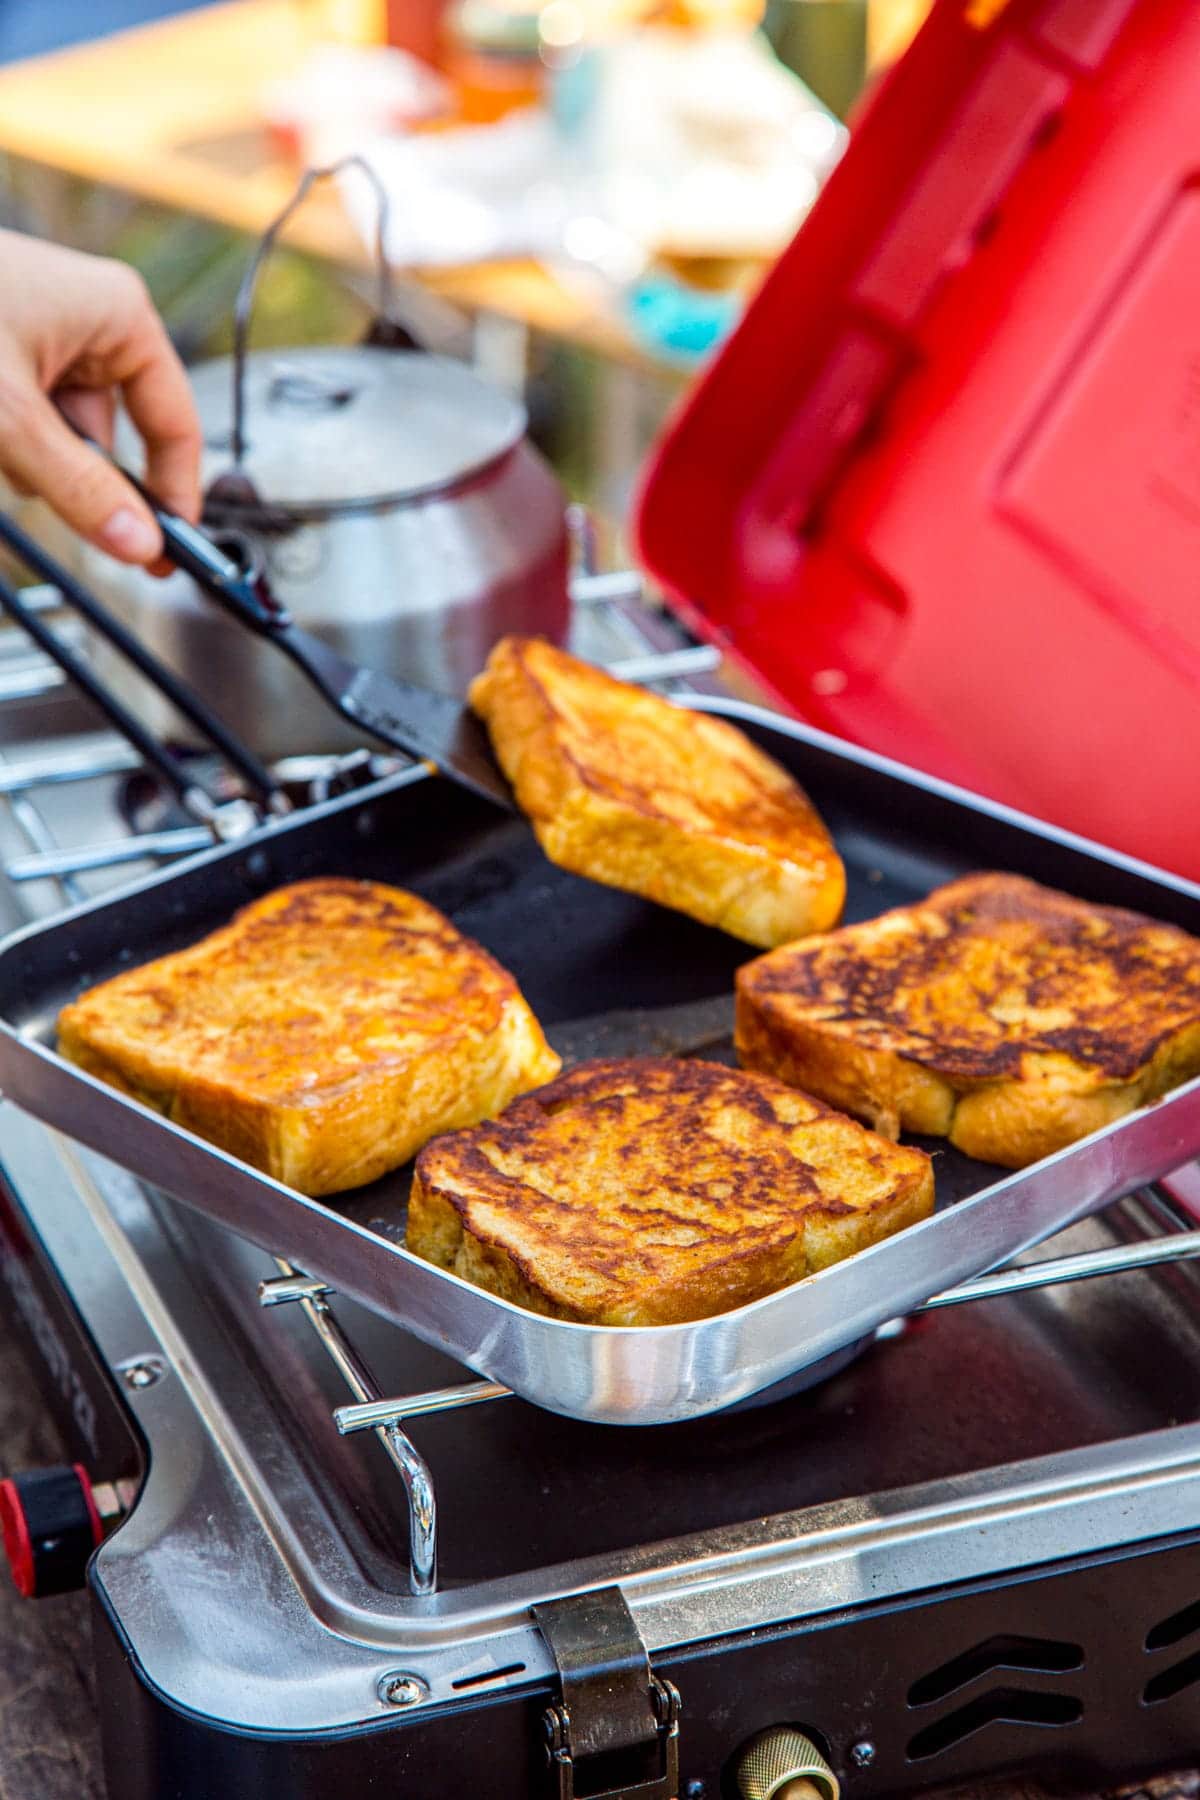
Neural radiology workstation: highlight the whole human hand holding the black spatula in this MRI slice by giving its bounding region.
[0,230,201,574]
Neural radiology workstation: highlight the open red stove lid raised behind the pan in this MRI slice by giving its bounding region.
[637,0,1200,878]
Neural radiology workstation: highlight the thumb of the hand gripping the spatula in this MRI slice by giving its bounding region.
[0,382,162,563]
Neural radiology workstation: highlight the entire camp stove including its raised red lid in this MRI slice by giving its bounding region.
[0,0,1200,1800]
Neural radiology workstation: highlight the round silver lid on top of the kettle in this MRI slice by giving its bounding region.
[191,346,527,517]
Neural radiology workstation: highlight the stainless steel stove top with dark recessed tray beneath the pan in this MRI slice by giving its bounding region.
[0,579,1200,1771]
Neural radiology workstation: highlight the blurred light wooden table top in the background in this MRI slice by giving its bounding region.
[0,0,648,365]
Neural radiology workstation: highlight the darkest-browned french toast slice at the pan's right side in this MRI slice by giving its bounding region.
[736,875,1200,1168]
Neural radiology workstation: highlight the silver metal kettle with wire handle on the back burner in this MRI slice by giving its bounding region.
[85,162,569,758]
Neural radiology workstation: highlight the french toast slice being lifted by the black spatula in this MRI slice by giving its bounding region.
[470,637,846,945]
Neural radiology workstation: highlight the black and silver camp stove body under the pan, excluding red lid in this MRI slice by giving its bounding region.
[0,578,1200,1800]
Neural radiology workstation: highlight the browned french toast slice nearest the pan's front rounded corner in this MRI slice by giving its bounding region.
[407,1057,934,1325]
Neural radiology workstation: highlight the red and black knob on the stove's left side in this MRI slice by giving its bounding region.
[0,1463,104,1600]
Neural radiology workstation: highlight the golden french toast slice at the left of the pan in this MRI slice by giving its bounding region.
[58,880,560,1195]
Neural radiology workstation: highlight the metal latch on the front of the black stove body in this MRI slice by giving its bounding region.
[533,1588,680,1800]
